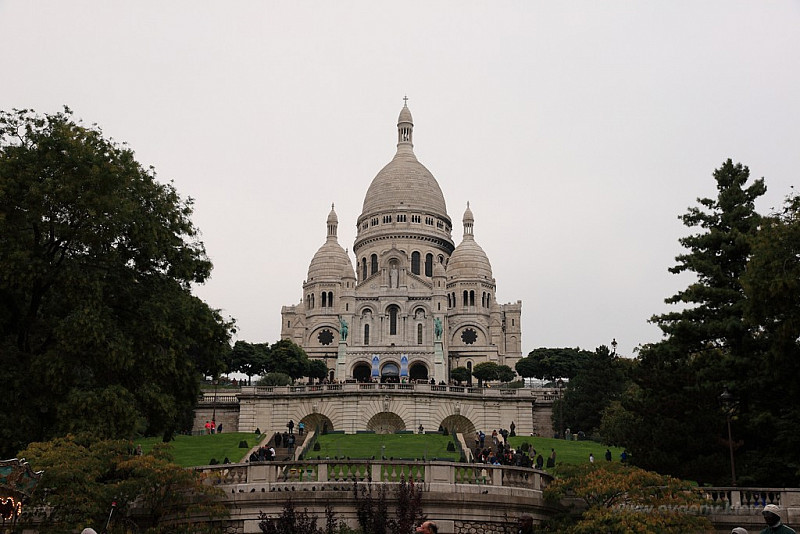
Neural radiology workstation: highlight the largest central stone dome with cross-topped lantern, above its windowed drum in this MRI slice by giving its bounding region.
[360,106,450,221]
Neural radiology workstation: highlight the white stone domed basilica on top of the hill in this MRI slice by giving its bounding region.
[281,102,522,383]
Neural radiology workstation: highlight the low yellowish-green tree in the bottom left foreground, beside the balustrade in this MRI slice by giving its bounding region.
[17,435,228,534]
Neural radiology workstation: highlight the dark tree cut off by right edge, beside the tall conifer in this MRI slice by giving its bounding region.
[740,194,800,486]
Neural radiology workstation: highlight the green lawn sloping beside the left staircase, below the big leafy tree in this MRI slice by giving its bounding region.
[135,432,264,467]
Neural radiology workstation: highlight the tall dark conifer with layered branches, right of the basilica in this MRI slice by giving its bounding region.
[624,160,766,482]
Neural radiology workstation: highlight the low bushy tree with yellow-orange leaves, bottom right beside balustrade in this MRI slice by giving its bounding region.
[544,462,714,534]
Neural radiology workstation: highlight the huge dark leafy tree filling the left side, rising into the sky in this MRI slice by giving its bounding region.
[0,110,233,456]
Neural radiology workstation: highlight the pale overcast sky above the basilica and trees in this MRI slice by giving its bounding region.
[0,0,800,355]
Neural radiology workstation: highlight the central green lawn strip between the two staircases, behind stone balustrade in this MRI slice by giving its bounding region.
[306,434,459,461]
